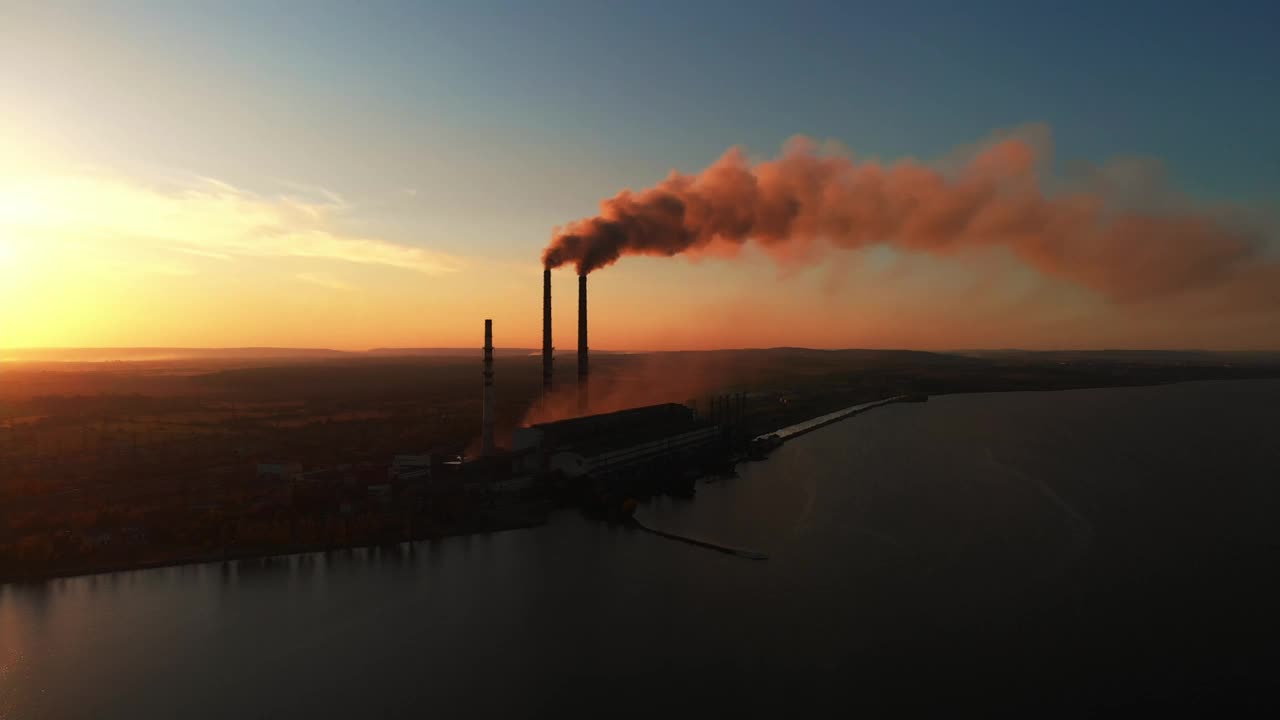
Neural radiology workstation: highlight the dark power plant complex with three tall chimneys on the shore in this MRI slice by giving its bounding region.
[463,269,749,516]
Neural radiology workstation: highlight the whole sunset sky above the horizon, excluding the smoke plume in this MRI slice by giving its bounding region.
[0,0,1280,350]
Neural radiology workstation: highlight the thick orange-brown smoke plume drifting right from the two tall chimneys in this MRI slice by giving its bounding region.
[543,133,1280,304]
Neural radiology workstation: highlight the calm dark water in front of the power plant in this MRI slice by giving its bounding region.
[0,380,1280,720]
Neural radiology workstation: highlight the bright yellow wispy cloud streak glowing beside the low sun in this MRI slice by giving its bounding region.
[0,174,462,274]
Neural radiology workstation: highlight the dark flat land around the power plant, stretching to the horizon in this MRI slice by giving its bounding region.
[0,348,1280,582]
